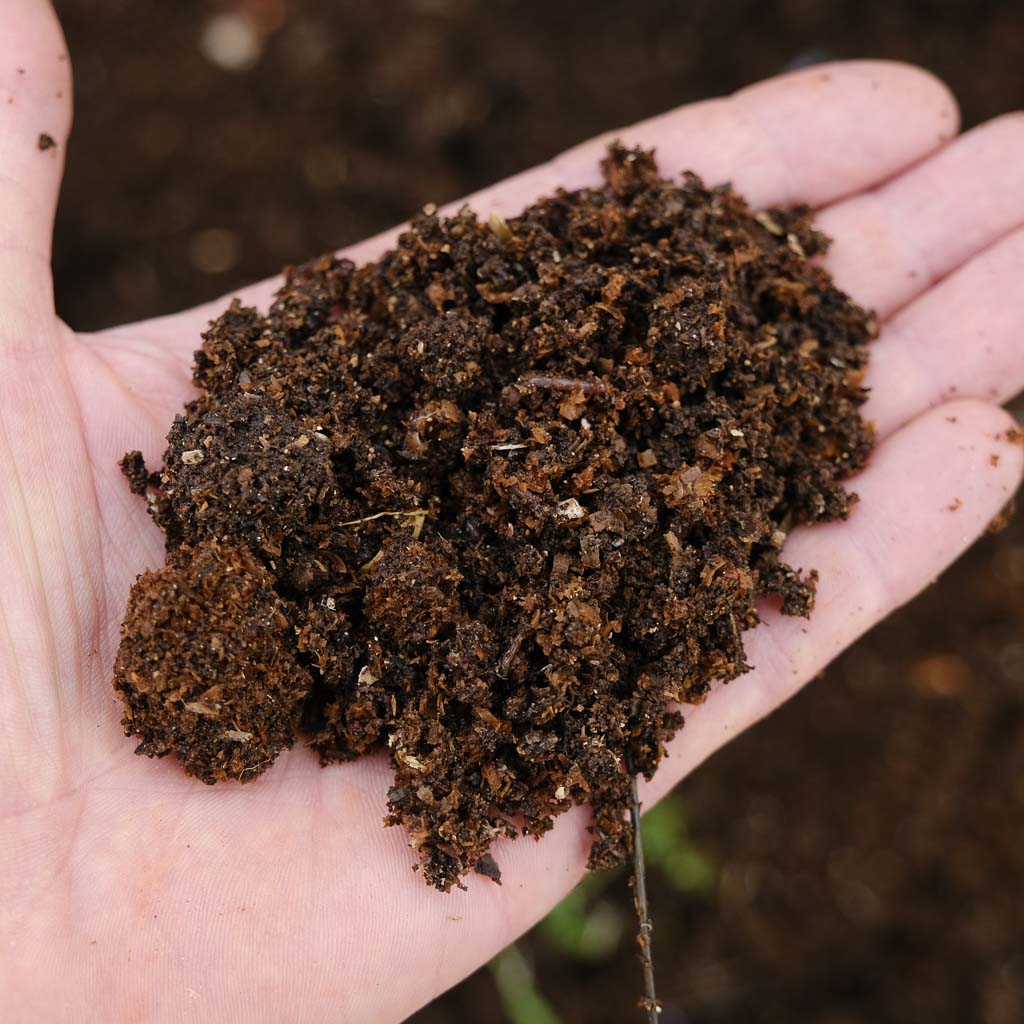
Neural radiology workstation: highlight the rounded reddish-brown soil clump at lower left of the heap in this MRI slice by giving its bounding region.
[114,540,310,782]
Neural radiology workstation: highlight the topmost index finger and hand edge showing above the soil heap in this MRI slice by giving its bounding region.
[116,61,957,358]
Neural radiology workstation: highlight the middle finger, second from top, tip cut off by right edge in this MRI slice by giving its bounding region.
[818,114,1024,317]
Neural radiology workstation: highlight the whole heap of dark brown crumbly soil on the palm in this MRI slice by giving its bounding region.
[115,146,876,890]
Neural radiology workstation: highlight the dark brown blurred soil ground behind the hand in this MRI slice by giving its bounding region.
[54,0,1024,1024]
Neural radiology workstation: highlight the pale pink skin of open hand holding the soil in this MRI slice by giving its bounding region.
[0,0,1024,1022]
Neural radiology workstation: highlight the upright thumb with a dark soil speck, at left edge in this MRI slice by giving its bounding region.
[0,0,72,316]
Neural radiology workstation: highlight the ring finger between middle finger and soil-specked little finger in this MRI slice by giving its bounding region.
[864,228,1024,435]
